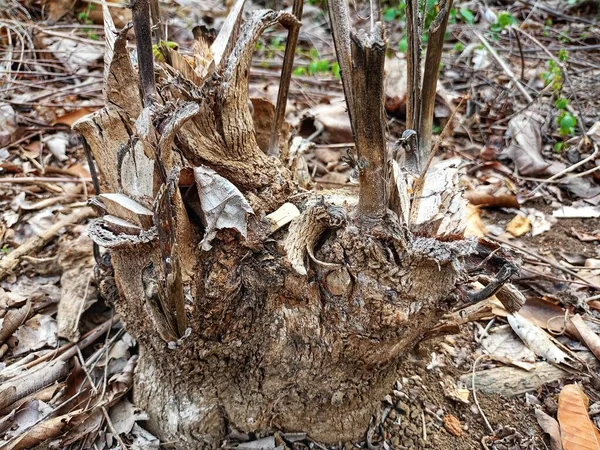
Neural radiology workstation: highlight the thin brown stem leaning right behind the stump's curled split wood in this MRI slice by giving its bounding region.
[268,0,304,155]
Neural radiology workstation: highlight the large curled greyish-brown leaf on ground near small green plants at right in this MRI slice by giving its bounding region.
[502,111,550,175]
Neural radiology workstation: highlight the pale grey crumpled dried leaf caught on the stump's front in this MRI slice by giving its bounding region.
[194,166,254,250]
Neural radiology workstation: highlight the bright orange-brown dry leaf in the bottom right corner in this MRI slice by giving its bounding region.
[558,384,600,450]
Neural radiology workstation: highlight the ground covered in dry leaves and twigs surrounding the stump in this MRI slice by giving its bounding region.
[0,0,600,450]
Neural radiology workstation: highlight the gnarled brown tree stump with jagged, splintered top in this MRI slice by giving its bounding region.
[74,0,516,448]
